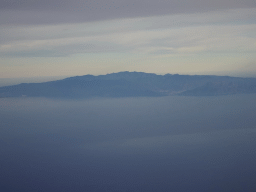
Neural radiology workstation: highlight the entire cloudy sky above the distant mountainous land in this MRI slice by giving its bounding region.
[0,0,256,78]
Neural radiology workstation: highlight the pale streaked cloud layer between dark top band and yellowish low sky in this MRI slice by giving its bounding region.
[0,9,256,57]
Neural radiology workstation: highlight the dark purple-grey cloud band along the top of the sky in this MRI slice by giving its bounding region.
[0,0,256,25]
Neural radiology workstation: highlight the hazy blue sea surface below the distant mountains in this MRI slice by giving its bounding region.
[0,94,256,192]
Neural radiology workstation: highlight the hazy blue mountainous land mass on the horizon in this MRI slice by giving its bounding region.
[0,71,256,99]
